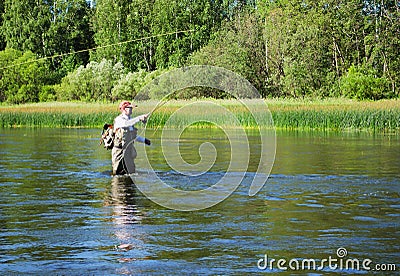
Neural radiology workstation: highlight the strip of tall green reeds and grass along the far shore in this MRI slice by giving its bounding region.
[0,99,400,132]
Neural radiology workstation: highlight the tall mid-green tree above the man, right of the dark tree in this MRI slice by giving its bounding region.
[92,0,157,71]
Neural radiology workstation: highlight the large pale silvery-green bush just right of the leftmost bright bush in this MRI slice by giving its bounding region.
[55,59,125,101]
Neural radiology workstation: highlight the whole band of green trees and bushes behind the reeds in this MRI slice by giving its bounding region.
[0,0,400,103]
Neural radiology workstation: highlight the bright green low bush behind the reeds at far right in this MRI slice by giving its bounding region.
[340,65,393,100]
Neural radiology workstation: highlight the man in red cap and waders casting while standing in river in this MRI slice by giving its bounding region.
[111,101,151,175]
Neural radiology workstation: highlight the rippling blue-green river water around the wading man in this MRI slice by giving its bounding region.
[0,128,400,275]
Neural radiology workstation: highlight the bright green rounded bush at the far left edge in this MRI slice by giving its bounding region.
[0,49,48,103]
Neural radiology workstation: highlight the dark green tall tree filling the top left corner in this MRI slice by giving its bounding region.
[1,0,93,81]
